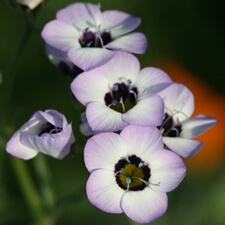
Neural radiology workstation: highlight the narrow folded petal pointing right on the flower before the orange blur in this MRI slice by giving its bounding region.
[180,114,217,138]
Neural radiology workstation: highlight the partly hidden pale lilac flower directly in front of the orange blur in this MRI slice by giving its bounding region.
[159,83,217,158]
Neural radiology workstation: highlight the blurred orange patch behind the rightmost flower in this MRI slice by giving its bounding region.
[157,60,225,174]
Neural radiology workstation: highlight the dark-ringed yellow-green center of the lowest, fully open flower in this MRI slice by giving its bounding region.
[114,155,151,191]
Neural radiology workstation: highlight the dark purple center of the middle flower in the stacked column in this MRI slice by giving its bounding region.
[104,82,138,113]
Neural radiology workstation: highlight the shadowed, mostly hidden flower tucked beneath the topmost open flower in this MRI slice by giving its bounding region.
[45,44,83,78]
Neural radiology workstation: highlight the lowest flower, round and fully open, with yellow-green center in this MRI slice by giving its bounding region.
[84,125,186,223]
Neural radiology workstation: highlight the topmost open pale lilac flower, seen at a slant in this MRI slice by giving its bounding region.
[42,3,147,70]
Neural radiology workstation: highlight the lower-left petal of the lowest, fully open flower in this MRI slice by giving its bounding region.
[86,170,124,213]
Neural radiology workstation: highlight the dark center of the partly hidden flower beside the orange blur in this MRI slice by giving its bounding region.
[158,113,182,137]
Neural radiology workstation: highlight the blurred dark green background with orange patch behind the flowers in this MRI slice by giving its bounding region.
[0,0,225,225]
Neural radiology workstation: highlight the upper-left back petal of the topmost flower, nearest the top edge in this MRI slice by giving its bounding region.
[56,3,102,31]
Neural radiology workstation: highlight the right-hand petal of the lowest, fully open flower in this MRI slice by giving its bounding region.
[149,150,186,193]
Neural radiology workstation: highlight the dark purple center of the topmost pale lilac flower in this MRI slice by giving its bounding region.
[79,29,112,48]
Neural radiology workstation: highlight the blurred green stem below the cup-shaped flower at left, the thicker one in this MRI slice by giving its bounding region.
[12,157,45,220]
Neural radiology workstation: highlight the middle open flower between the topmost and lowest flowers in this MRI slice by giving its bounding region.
[71,52,172,132]
